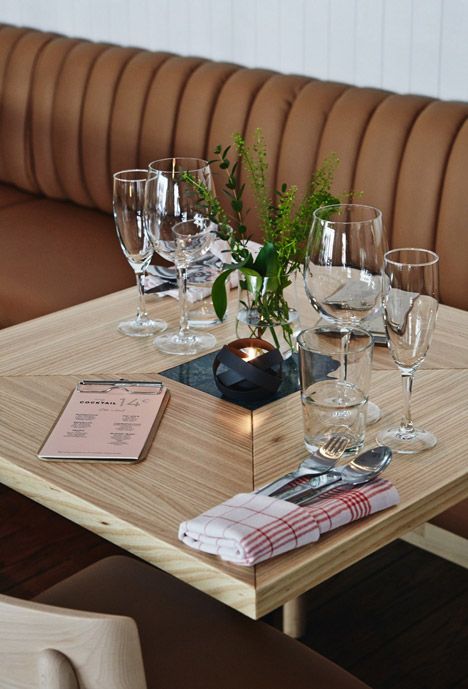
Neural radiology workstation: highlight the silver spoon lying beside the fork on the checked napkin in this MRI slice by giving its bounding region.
[272,445,392,505]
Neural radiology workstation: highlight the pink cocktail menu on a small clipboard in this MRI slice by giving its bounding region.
[38,380,169,462]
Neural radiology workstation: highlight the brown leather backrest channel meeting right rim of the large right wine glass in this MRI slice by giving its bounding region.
[354,94,429,243]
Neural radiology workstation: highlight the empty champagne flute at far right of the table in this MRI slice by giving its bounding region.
[377,249,439,454]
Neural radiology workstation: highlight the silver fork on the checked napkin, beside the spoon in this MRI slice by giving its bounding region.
[255,433,350,496]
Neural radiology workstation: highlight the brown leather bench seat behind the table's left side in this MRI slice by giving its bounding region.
[0,187,135,327]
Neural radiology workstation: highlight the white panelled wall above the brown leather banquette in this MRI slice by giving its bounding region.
[0,0,468,100]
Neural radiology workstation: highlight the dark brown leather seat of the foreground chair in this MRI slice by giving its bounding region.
[36,556,372,689]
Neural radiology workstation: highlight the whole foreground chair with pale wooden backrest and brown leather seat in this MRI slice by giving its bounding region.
[0,556,369,689]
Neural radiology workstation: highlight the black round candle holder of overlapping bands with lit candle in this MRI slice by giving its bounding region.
[213,337,283,402]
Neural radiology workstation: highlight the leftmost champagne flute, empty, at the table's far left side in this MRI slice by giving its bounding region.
[113,170,167,337]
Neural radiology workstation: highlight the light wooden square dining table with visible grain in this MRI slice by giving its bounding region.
[0,290,468,618]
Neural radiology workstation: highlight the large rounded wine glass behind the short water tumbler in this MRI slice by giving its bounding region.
[304,203,387,423]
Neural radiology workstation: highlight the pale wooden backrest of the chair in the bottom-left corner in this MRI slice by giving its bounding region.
[0,595,146,689]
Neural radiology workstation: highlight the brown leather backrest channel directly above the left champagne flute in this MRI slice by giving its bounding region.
[109,51,170,175]
